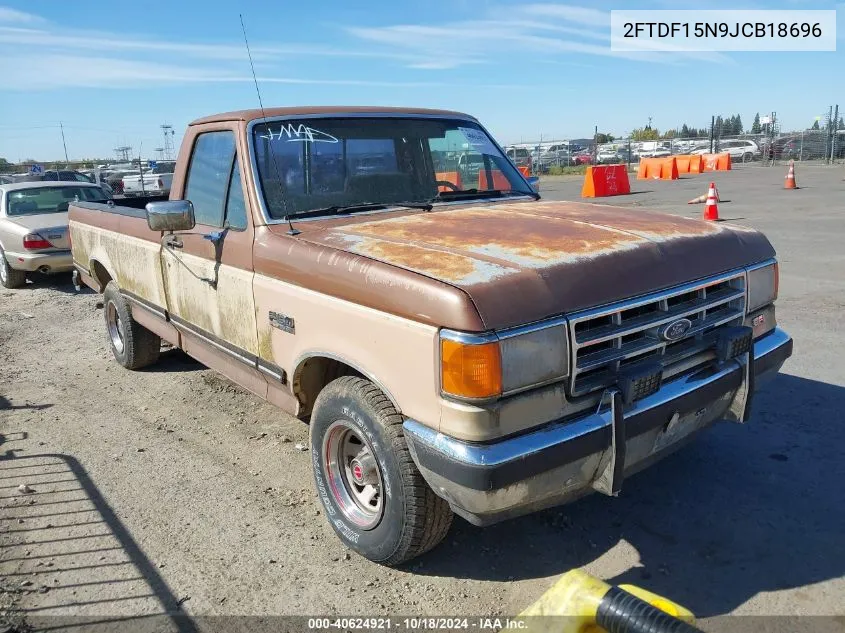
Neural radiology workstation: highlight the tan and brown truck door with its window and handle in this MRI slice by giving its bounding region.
[162,130,267,395]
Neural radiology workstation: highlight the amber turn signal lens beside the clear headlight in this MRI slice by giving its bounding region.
[440,339,502,398]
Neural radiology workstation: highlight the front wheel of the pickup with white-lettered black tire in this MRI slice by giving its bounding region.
[309,376,453,566]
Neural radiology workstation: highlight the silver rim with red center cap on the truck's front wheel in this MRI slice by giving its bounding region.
[323,420,384,530]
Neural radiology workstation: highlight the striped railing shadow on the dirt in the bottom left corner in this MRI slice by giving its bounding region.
[0,433,197,633]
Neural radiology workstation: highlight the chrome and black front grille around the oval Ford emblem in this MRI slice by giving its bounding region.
[569,271,745,396]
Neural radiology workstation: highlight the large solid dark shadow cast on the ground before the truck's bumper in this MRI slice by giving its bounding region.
[418,374,845,617]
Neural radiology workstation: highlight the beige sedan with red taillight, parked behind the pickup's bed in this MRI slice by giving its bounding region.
[0,181,110,288]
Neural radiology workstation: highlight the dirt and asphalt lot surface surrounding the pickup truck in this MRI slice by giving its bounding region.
[0,167,845,630]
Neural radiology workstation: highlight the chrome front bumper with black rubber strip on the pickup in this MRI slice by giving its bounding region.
[404,328,792,525]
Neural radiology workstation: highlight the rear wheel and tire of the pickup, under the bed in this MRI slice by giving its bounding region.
[103,281,161,369]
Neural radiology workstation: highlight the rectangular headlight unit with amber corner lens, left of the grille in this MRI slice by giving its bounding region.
[440,319,569,399]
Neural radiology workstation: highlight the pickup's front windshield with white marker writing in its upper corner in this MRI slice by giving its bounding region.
[253,117,533,219]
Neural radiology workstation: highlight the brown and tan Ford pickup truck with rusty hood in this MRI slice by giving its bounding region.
[70,107,792,565]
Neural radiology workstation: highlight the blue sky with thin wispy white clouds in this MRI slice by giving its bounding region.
[0,0,845,161]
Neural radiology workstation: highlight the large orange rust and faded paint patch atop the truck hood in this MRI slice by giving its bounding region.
[320,202,722,276]
